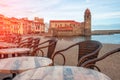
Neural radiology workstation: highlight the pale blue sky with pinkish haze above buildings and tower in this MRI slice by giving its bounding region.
[0,0,120,25]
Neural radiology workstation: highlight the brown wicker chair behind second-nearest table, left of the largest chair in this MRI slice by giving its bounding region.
[31,39,57,58]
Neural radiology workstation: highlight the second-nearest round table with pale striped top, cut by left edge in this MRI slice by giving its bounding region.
[0,56,52,77]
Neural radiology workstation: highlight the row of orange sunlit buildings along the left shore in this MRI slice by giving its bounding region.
[0,14,45,34]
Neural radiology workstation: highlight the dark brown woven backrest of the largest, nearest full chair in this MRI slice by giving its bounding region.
[78,40,102,65]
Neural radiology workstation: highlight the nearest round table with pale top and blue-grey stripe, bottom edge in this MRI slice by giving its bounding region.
[13,66,111,80]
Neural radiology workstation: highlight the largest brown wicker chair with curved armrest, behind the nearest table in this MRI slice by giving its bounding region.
[52,40,102,65]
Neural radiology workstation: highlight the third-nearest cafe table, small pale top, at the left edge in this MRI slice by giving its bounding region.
[0,48,30,59]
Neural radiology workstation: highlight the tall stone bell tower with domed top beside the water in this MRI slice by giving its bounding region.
[84,9,91,36]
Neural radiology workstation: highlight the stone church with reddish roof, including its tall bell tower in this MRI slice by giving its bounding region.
[49,9,91,37]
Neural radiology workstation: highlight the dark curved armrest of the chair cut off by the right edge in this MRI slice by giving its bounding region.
[79,48,120,71]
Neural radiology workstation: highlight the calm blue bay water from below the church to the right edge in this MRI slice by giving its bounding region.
[49,34,120,44]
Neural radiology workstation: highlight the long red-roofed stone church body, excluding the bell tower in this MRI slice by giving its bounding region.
[50,20,83,36]
